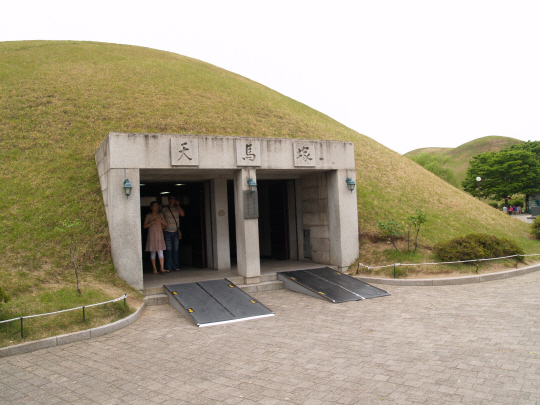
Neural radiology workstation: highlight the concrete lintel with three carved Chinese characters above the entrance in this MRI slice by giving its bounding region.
[107,132,354,170]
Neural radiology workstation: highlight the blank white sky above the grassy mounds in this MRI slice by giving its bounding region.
[0,0,540,153]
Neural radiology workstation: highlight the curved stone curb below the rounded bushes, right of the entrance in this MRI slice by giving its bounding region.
[355,264,540,286]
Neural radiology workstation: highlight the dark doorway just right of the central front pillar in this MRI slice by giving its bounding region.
[257,180,290,260]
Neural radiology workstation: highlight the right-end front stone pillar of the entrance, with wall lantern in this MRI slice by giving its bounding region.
[327,170,359,269]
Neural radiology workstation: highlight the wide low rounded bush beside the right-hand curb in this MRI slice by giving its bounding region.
[435,233,524,262]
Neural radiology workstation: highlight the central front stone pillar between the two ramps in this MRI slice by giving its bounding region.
[234,168,261,284]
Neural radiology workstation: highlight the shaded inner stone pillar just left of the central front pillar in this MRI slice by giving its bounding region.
[210,179,231,270]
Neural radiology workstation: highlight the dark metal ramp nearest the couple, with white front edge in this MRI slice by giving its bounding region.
[164,279,274,327]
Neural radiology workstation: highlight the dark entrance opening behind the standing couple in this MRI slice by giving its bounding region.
[140,182,208,273]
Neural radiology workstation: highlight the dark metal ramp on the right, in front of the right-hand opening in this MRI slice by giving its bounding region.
[277,267,390,303]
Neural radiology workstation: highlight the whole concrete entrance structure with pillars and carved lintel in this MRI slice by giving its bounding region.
[95,133,358,290]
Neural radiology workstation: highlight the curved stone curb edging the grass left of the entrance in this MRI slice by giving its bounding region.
[0,303,146,358]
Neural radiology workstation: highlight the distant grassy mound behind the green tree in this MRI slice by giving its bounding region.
[403,135,523,188]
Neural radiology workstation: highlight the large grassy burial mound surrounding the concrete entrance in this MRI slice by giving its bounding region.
[0,41,536,296]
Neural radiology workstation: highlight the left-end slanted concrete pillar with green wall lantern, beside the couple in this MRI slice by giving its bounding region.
[107,169,143,290]
